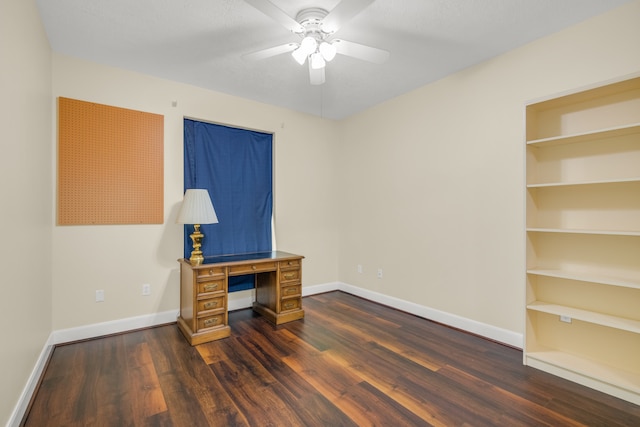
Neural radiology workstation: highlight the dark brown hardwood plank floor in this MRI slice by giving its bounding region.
[24,292,640,427]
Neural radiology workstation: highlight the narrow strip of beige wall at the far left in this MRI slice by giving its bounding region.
[0,0,53,425]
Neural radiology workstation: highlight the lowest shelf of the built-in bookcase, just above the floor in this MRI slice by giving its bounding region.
[526,349,640,398]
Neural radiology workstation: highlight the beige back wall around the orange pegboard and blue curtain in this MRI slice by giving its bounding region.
[51,54,338,330]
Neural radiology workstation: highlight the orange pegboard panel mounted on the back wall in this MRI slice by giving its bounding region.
[58,97,164,225]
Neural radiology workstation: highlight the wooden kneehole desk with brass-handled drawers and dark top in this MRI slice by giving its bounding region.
[178,251,304,345]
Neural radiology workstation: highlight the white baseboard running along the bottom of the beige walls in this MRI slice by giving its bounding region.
[7,282,523,427]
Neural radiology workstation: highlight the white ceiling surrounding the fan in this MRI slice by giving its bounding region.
[37,0,629,119]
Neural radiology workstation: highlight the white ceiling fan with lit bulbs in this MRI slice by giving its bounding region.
[243,0,389,85]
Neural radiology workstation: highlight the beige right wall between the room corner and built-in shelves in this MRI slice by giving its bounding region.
[338,1,640,333]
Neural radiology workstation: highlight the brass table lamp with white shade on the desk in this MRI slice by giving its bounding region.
[176,188,218,265]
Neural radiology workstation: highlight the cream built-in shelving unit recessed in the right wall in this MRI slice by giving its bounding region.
[524,76,640,404]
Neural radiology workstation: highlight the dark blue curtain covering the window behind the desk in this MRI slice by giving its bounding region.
[184,119,273,291]
